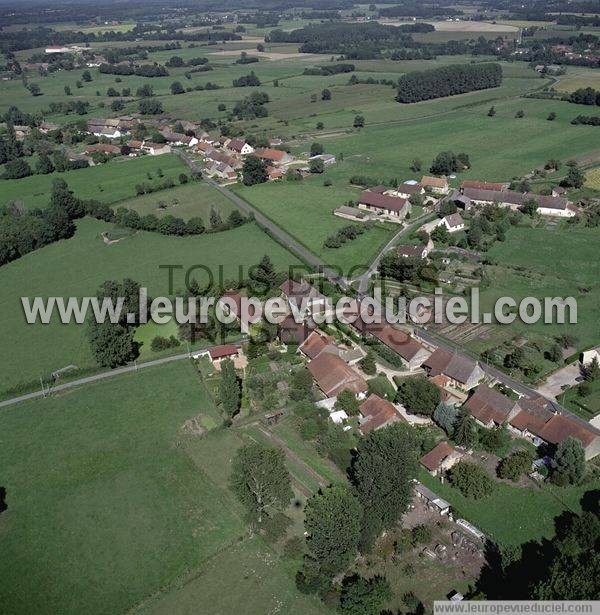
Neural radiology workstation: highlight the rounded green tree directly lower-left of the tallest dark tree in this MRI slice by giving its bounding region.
[304,485,363,576]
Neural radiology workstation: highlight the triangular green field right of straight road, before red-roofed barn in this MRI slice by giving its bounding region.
[235,176,400,275]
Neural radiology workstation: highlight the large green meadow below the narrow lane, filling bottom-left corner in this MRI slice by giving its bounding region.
[0,362,324,615]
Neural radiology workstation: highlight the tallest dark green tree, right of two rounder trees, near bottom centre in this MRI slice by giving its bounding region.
[352,423,417,552]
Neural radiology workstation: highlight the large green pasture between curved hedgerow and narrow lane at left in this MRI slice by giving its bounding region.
[0,218,298,392]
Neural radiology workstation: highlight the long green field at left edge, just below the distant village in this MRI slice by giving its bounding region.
[0,154,189,209]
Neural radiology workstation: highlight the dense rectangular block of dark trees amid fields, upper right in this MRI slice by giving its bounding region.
[396,63,502,103]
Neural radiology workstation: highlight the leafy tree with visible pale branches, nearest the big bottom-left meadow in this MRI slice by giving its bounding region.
[231,442,294,524]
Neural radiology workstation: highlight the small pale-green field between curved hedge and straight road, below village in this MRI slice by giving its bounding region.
[118,182,235,221]
